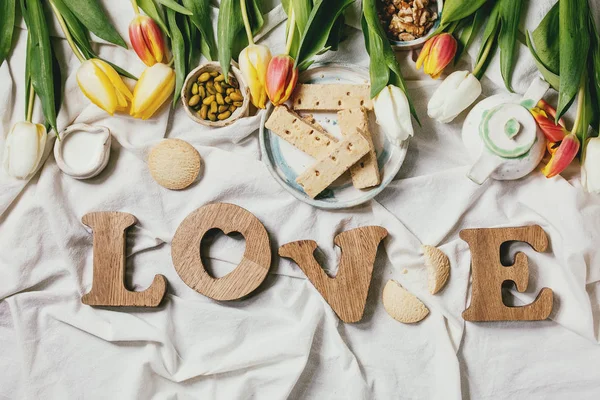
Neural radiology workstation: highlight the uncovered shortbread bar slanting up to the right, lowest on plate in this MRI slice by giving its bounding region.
[296,132,370,199]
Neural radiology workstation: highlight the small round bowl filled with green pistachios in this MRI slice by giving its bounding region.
[181,62,250,128]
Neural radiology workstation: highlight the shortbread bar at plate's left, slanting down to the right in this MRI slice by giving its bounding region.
[265,106,338,159]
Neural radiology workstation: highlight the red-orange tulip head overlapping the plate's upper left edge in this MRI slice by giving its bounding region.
[266,55,298,106]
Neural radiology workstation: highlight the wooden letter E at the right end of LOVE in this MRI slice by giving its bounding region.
[460,226,554,322]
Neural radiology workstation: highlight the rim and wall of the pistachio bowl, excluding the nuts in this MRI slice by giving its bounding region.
[181,62,250,128]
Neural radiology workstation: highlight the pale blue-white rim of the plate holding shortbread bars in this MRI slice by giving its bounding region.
[259,62,410,210]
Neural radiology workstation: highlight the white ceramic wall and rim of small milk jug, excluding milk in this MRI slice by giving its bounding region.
[54,124,112,180]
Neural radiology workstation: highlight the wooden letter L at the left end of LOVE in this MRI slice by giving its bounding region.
[81,212,167,307]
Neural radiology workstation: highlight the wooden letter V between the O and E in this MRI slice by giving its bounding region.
[279,226,388,323]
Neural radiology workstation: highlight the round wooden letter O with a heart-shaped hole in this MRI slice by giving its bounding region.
[171,203,271,301]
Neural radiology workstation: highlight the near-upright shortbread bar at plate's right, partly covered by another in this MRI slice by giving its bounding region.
[338,107,381,189]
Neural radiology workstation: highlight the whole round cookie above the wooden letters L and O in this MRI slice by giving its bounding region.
[148,139,202,190]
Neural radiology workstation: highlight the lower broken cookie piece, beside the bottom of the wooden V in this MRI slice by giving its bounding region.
[383,280,429,324]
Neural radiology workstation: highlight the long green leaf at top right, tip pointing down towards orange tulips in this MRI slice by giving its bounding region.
[556,0,590,122]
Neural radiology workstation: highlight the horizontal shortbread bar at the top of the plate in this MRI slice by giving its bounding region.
[292,84,373,111]
